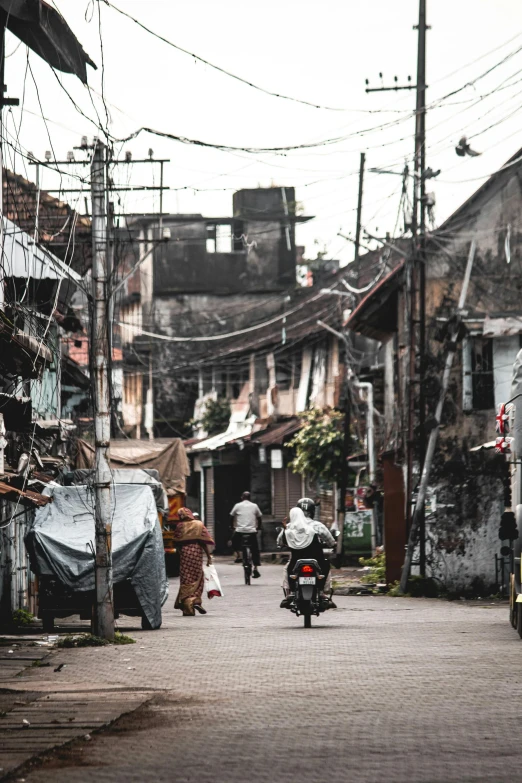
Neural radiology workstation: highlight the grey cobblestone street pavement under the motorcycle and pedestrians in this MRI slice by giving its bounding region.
[3,565,522,783]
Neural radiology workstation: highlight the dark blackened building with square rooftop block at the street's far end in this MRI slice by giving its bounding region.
[115,187,309,437]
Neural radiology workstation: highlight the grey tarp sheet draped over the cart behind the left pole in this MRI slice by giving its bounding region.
[25,484,168,628]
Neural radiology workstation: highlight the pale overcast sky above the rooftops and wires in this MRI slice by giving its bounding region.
[5,0,522,263]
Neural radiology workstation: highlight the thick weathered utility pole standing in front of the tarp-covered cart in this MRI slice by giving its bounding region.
[91,140,114,640]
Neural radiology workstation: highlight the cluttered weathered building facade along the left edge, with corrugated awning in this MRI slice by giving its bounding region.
[0,213,87,619]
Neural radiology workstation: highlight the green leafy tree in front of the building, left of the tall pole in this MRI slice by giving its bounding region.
[289,408,344,483]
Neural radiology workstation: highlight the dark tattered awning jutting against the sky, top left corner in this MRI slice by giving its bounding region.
[0,0,96,84]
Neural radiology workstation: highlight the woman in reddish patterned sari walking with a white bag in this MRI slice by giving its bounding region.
[174,508,214,617]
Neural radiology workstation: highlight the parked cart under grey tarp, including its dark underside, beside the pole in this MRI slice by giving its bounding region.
[25,484,168,631]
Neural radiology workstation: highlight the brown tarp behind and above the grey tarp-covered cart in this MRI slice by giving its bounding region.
[75,438,190,493]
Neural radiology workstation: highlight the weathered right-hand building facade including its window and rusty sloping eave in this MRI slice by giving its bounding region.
[346,147,522,593]
